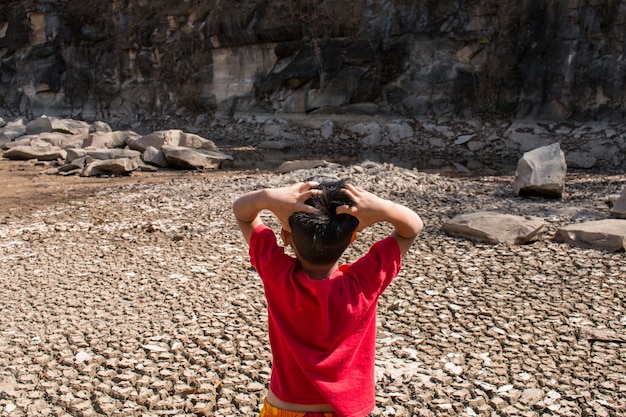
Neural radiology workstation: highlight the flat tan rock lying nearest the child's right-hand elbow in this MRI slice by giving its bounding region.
[443,211,545,245]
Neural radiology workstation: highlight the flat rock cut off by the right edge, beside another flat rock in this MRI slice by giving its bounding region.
[554,219,626,252]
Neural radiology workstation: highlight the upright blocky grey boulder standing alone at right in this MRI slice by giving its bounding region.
[513,143,567,198]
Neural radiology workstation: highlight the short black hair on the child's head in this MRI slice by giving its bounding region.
[289,180,359,265]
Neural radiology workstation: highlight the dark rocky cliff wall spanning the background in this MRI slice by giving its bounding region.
[0,0,626,121]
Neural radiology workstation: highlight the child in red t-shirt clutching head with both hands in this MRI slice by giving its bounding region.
[233,177,423,417]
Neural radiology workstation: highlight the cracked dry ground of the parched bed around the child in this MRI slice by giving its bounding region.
[0,162,626,416]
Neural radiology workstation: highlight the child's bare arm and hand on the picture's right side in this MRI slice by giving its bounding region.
[337,184,424,255]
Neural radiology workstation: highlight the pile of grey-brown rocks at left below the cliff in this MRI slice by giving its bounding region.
[0,116,233,176]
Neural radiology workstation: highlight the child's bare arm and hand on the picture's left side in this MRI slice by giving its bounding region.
[233,182,321,243]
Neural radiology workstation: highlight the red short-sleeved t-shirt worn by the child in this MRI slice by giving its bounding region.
[250,225,402,417]
